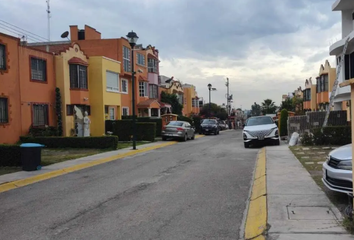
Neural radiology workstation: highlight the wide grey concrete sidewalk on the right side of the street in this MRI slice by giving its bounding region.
[266,145,354,240]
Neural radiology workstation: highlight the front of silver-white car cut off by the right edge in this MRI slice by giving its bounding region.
[322,144,353,194]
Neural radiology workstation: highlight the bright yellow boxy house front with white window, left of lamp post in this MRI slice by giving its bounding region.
[89,56,124,136]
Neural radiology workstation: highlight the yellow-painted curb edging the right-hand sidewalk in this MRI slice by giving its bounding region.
[245,148,267,240]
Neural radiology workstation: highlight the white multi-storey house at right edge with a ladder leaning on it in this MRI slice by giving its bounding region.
[329,0,354,110]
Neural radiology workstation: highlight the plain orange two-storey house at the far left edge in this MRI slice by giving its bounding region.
[0,33,56,143]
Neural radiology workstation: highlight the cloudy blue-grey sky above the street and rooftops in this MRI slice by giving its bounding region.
[0,0,341,109]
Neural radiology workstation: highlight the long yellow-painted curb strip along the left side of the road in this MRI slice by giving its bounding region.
[0,136,204,193]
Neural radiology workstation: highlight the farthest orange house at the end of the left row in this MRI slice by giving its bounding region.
[182,84,200,116]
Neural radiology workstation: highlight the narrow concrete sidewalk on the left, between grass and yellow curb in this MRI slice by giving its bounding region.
[0,141,176,186]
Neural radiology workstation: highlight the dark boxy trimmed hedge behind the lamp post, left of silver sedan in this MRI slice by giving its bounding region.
[106,119,156,142]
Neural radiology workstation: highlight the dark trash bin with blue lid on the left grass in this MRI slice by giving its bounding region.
[20,143,45,171]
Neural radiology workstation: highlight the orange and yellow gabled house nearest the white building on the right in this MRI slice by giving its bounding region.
[316,60,336,110]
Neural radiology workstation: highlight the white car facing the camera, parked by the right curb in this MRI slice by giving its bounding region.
[242,116,280,148]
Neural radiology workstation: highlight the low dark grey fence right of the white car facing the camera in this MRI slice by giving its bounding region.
[288,111,348,137]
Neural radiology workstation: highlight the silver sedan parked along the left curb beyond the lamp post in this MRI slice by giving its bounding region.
[161,121,195,141]
